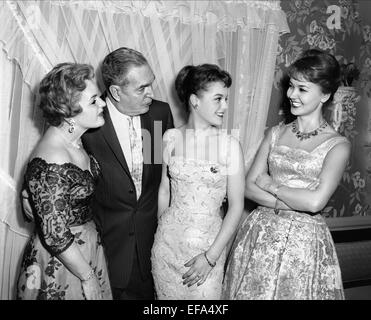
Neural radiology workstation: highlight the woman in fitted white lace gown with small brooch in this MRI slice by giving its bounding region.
[152,64,244,299]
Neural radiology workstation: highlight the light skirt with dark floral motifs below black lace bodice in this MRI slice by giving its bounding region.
[17,221,112,300]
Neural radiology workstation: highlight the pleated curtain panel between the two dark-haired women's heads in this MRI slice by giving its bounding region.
[229,25,279,168]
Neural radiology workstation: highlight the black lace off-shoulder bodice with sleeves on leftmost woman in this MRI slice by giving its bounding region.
[25,156,100,254]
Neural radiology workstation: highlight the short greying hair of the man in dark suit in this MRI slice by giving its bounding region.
[101,47,149,91]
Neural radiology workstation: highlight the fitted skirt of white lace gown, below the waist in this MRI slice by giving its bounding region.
[151,207,226,300]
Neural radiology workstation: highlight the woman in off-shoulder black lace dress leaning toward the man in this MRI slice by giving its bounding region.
[17,63,112,300]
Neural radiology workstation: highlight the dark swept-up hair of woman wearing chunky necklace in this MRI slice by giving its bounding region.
[288,49,341,106]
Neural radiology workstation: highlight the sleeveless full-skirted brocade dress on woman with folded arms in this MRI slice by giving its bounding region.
[223,126,347,300]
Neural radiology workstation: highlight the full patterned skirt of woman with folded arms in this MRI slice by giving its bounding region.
[223,207,344,300]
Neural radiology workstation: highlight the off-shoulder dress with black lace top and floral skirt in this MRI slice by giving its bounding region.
[17,157,112,300]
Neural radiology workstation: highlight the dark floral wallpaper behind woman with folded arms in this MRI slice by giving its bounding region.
[267,0,371,217]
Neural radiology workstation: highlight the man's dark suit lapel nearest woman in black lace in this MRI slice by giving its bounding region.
[102,108,131,178]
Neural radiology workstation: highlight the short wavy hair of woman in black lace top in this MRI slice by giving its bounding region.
[39,62,94,126]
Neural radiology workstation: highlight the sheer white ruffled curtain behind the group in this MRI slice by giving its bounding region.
[0,0,288,299]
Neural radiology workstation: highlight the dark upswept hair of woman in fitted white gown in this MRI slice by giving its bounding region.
[175,64,232,112]
